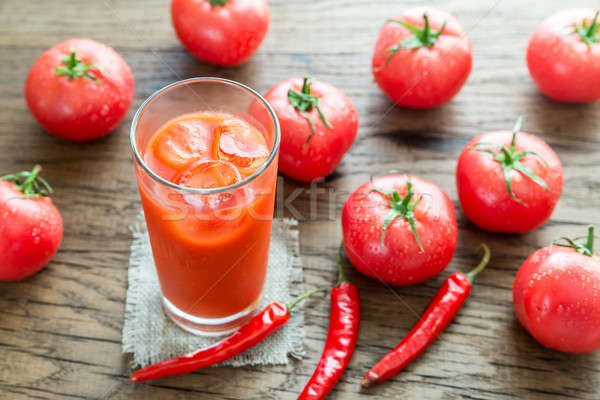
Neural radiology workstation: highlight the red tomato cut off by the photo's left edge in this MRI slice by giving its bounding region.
[0,167,63,281]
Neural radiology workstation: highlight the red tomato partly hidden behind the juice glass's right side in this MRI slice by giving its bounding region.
[251,78,358,182]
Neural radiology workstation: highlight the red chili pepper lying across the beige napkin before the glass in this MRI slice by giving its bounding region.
[129,289,322,382]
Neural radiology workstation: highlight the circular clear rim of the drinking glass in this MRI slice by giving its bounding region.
[129,77,281,194]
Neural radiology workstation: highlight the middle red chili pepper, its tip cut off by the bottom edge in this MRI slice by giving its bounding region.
[298,246,360,400]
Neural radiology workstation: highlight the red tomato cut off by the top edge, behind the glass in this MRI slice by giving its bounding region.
[171,0,269,67]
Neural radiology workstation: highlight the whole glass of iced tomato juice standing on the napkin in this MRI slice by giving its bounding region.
[130,78,280,336]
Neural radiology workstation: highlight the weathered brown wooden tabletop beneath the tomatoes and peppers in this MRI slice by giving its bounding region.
[0,0,600,400]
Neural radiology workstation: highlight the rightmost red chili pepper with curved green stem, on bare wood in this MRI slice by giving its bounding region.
[362,243,490,387]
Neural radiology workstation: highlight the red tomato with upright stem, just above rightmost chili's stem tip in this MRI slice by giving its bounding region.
[456,117,563,233]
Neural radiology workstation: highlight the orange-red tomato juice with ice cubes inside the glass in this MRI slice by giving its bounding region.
[138,112,277,332]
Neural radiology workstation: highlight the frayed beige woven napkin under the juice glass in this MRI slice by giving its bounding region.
[122,217,304,366]
